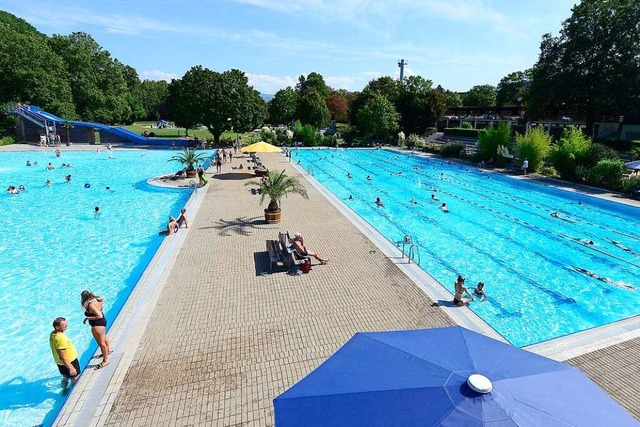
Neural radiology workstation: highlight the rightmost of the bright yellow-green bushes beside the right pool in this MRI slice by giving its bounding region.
[550,126,592,180]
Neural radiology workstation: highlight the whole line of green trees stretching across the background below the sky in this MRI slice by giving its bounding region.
[0,0,640,141]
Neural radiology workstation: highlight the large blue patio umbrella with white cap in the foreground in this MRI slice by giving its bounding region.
[274,327,639,427]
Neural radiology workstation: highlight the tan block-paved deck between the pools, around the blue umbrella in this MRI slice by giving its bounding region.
[28,145,640,426]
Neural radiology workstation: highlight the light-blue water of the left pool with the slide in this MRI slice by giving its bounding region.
[0,150,208,426]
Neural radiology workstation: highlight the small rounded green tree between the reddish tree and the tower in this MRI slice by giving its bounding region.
[358,93,400,139]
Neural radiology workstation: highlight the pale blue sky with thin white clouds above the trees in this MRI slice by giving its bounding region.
[0,0,577,94]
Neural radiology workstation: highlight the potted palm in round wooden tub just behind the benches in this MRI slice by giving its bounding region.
[245,170,309,224]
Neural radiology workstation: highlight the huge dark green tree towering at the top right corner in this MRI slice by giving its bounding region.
[527,0,640,130]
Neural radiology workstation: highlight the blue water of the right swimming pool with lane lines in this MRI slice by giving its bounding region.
[296,150,640,346]
